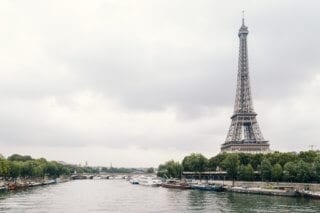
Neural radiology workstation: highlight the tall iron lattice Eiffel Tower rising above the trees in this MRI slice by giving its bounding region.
[221,17,270,153]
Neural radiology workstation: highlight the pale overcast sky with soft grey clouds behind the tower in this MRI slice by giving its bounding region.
[0,0,320,167]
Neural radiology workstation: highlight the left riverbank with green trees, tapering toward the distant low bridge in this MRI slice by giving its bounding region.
[0,154,150,192]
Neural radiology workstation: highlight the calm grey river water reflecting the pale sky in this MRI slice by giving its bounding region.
[0,180,320,213]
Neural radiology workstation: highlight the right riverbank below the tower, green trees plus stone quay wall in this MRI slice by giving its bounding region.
[157,151,320,196]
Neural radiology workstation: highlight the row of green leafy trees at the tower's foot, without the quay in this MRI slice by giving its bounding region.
[157,151,320,183]
